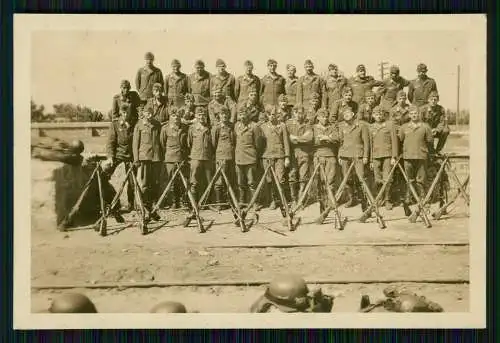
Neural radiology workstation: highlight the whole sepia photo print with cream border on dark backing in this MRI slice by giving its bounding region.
[14,15,486,328]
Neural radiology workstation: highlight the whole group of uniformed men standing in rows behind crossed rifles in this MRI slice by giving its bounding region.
[106,52,449,220]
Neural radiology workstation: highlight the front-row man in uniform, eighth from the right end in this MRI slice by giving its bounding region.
[212,107,236,209]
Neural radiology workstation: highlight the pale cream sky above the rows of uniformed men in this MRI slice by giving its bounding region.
[31,16,473,112]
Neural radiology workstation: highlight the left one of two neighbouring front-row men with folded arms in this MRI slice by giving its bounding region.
[286,108,313,204]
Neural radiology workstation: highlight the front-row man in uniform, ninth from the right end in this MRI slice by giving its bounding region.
[188,107,214,201]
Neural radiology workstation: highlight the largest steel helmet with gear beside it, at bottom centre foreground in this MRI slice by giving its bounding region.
[250,274,334,313]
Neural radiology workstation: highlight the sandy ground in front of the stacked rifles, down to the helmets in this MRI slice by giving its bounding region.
[32,205,469,312]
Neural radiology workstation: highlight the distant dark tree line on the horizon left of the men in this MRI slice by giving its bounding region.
[31,100,104,122]
